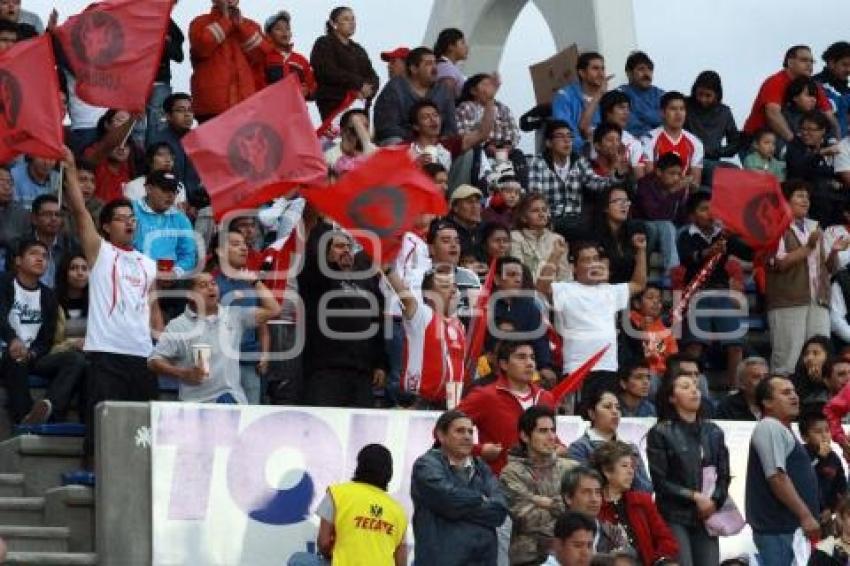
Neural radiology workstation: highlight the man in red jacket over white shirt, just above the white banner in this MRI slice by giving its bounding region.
[458,340,555,475]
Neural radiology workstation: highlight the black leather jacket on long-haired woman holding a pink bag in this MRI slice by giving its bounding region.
[646,420,732,526]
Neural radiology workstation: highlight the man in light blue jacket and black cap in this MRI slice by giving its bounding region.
[133,171,197,275]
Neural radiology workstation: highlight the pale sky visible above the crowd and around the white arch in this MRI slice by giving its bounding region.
[23,0,850,153]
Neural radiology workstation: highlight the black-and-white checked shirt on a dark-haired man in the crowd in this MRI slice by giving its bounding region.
[528,154,623,218]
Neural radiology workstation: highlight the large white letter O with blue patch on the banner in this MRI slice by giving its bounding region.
[227,411,344,525]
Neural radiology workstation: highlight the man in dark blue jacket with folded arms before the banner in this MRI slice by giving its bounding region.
[410,410,508,566]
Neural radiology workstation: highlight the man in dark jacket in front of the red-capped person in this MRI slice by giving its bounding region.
[374,47,457,145]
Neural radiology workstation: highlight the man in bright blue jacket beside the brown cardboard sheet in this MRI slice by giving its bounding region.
[552,51,608,152]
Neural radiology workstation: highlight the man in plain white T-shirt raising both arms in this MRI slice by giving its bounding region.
[537,237,646,397]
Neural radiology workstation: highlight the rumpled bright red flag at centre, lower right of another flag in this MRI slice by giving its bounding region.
[303,151,447,264]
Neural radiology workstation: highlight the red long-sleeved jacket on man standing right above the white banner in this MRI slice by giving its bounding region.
[458,377,555,476]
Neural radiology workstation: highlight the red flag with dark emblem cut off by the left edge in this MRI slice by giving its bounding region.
[0,35,64,163]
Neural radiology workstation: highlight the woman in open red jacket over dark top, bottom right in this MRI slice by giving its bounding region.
[592,440,679,566]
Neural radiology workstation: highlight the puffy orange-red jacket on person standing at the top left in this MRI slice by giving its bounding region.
[189,8,274,116]
